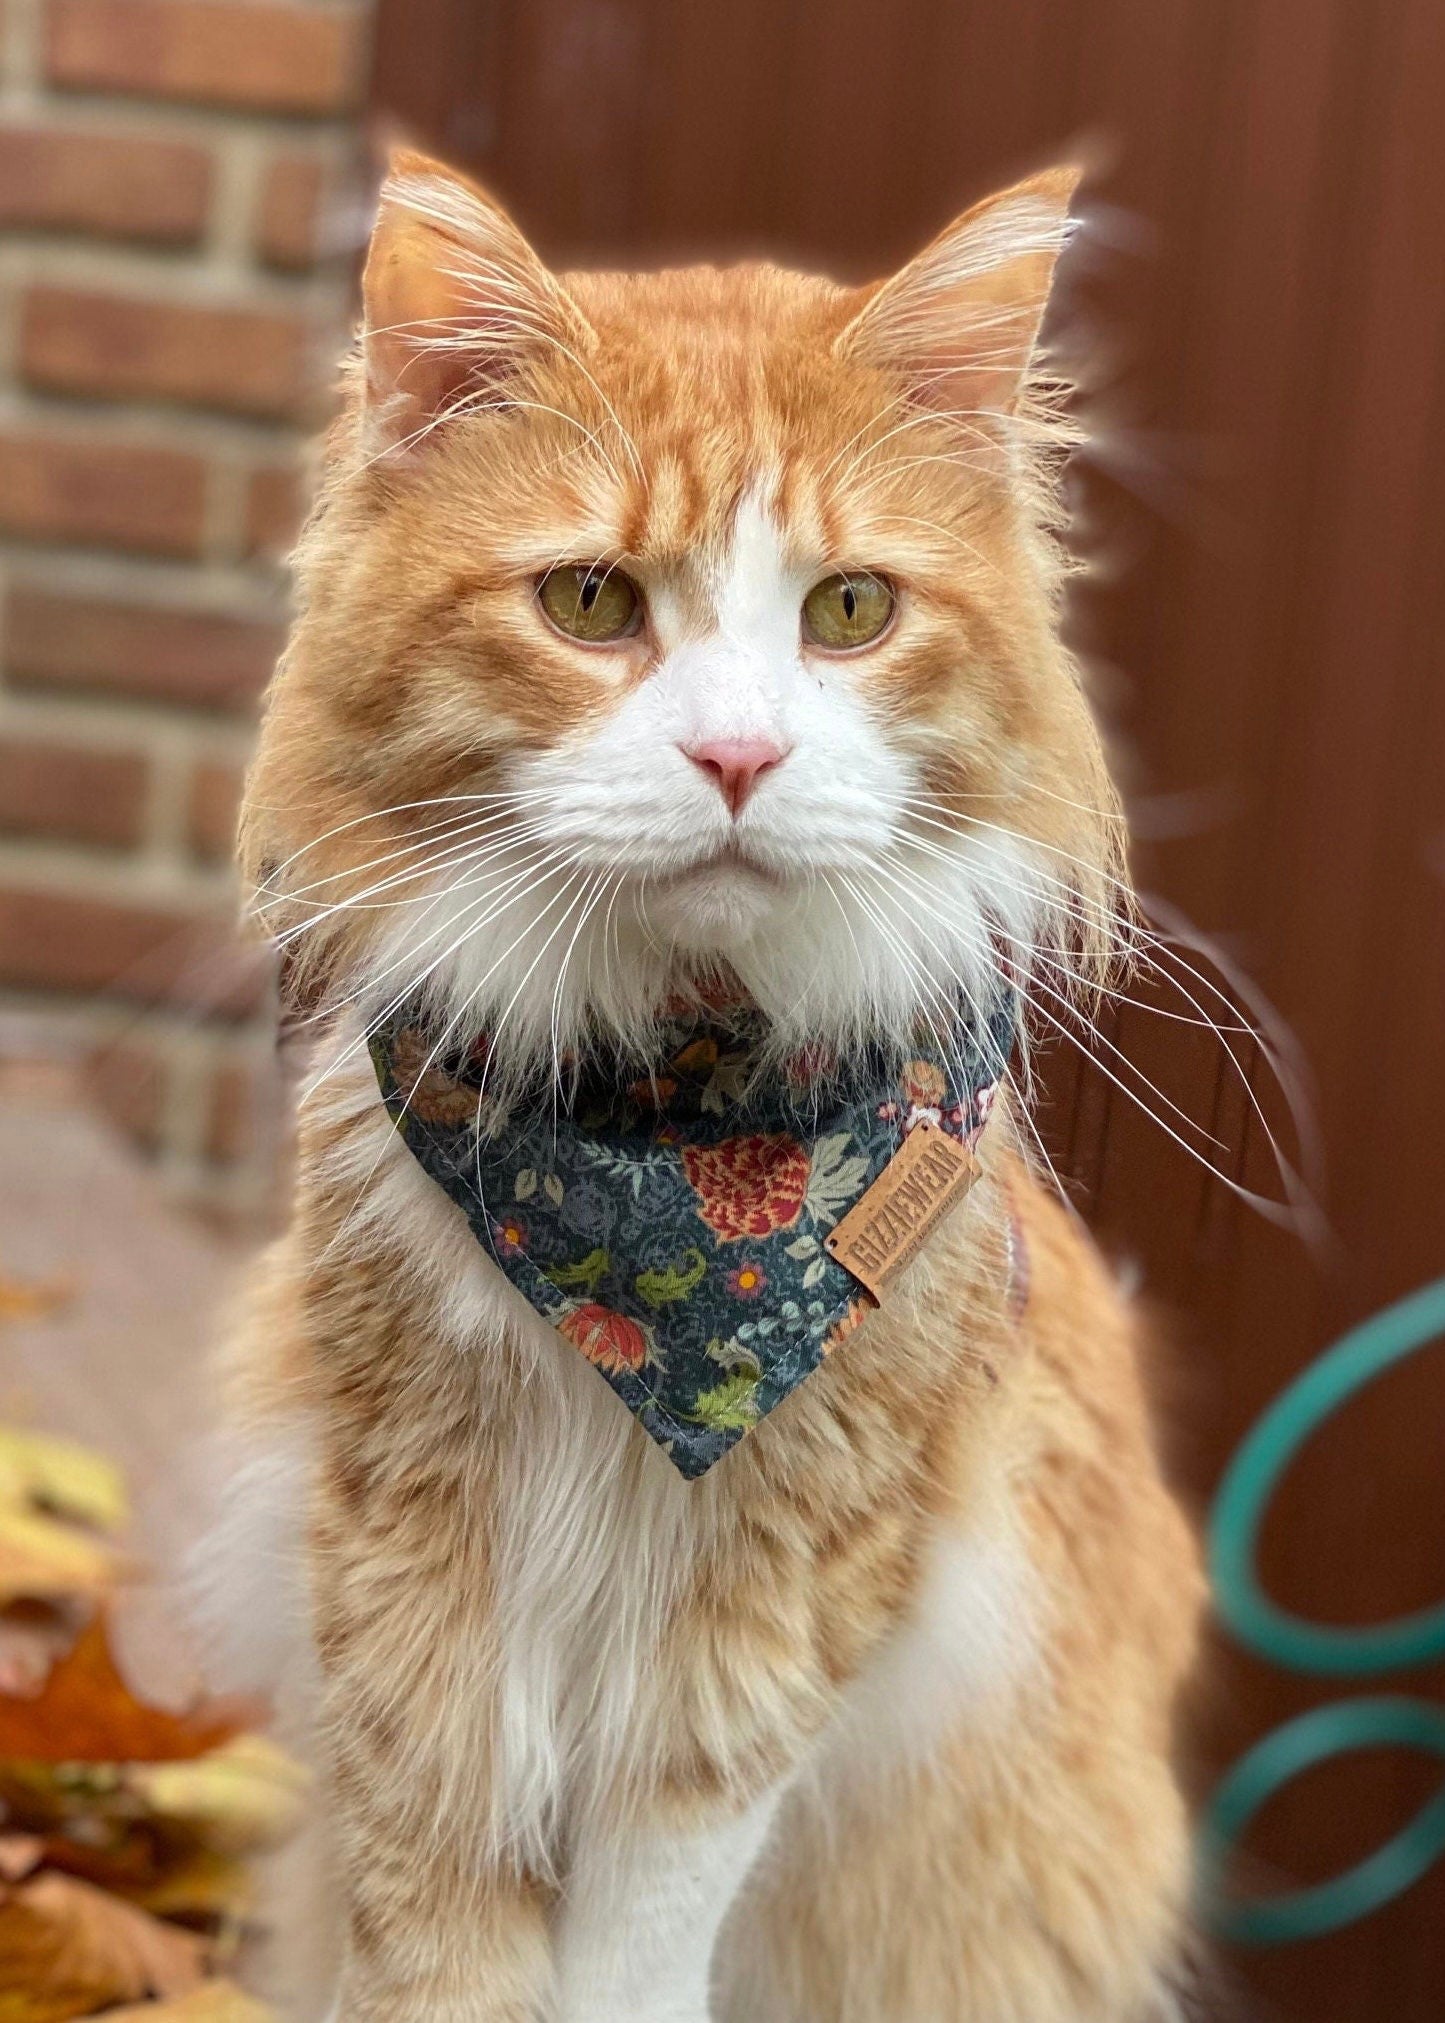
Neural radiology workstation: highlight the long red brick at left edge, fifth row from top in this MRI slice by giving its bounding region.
[4,583,283,710]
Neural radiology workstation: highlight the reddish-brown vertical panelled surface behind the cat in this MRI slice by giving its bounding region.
[374,0,1445,2023]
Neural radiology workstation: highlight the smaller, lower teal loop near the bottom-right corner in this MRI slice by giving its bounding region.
[1202,1693,1445,1946]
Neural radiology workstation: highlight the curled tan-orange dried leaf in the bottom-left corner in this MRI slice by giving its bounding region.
[0,1871,206,2023]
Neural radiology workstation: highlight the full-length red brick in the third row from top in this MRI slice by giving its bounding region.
[20,287,308,417]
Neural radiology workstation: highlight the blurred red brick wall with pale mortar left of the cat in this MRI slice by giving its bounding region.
[0,0,368,1212]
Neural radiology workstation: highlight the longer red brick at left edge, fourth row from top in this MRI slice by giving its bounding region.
[0,431,206,554]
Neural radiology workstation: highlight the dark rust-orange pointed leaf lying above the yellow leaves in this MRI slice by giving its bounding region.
[0,1616,253,1764]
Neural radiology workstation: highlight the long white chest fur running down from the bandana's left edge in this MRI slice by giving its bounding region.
[319,1090,718,1877]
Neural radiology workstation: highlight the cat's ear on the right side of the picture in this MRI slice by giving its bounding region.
[836,168,1081,419]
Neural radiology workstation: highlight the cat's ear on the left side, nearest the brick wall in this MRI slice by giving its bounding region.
[362,148,591,455]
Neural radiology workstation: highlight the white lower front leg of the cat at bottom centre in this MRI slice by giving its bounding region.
[555,1792,779,2023]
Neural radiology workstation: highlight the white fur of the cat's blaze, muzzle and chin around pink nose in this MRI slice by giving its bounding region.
[356,496,1044,1058]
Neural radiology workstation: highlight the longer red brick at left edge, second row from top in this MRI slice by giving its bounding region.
[0,125,210,245]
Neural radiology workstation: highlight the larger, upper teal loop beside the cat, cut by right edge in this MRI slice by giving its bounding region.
[1210,1279,1445,1675]
